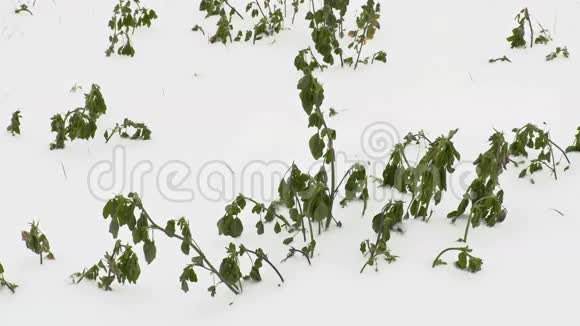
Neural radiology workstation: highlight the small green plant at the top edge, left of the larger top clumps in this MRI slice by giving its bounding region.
[105,0,157,57]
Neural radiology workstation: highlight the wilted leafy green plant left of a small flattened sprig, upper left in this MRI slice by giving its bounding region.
[50,84,107,150]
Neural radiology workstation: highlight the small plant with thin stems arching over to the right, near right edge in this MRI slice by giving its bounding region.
[509,123,570,183]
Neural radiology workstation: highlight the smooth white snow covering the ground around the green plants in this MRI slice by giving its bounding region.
[0,0,580,326]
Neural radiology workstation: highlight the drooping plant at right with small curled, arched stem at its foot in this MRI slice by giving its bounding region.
[433,131,510,273]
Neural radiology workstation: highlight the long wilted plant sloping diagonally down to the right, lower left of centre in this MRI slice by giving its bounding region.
[103,193,284,296]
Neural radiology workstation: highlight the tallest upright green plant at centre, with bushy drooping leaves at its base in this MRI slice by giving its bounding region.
[217,49,369,263]
